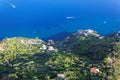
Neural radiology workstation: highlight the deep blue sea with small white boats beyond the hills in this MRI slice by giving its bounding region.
[0,0,120,39]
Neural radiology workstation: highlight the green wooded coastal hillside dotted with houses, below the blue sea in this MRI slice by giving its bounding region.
[0,29,120,80]
